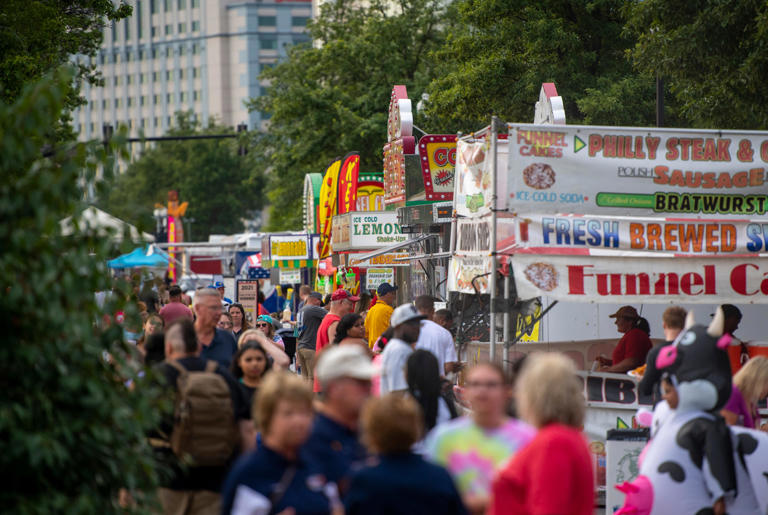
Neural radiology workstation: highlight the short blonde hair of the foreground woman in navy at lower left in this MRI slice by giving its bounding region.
[252,371,313,434]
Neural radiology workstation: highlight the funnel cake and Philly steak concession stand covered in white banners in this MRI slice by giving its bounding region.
[448,85,768,509]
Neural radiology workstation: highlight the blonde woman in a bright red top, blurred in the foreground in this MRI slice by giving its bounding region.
[488,353,595,515]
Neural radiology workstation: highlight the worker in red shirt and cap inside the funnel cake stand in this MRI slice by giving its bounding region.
[597,306,653,374]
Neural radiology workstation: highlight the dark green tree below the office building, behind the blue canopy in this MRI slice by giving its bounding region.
[99,113,263,241]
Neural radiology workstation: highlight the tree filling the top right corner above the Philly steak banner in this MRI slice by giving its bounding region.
[627,0,768,129]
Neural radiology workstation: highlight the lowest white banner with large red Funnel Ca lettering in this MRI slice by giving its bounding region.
[510,254,768,304]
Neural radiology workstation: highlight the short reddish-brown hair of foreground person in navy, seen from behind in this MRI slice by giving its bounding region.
[361,393,424,454]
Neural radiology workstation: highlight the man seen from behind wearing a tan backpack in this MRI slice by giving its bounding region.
[150,319,250,515]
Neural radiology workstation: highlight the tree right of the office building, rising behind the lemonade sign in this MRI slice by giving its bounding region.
[249,0,444,229]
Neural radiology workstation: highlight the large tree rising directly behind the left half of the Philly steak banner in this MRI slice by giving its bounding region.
[427,0,655,131]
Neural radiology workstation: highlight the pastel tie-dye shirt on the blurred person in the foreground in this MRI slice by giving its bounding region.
[425,417,536,497]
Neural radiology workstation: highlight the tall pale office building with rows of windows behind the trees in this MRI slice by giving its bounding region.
[73,0,312,139]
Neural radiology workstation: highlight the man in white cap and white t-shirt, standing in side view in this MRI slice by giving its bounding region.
[380,303,424,396]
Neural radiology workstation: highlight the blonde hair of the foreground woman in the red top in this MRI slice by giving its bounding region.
[515,352,586,429]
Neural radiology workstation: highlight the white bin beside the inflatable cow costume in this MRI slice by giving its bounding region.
[605,427,650,514]
